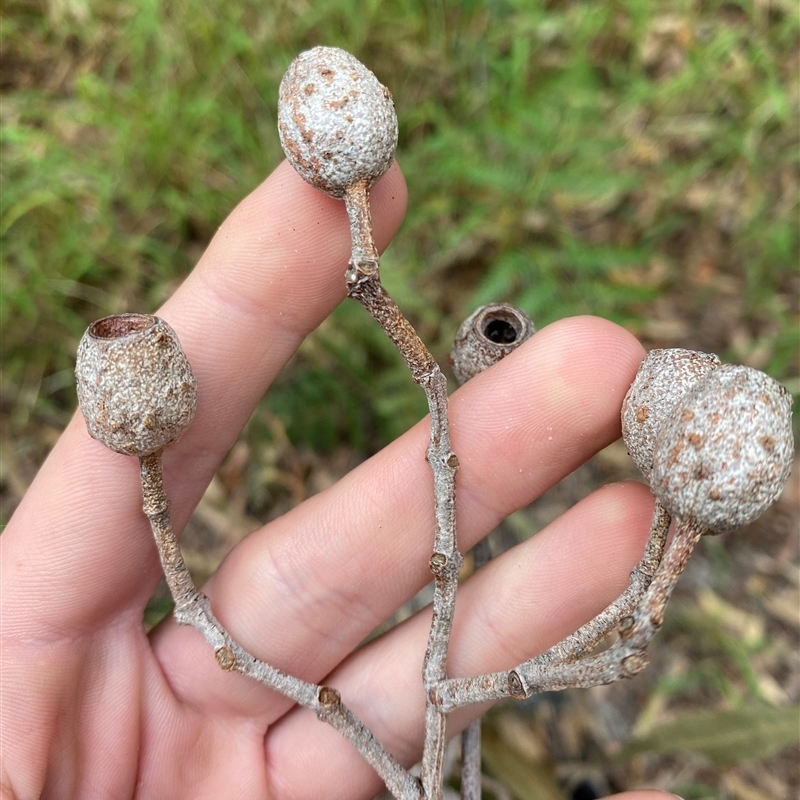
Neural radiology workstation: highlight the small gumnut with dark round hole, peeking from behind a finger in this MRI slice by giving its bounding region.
[450,303,534,385]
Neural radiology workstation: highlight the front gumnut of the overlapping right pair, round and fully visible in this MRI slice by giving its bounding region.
[651,364,794,532]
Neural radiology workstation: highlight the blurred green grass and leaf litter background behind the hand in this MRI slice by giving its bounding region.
[0,0,800,800]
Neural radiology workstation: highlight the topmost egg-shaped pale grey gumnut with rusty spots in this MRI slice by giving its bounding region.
[278,47,397,198]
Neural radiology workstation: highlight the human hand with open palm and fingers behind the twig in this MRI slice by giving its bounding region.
[0,158,676,800]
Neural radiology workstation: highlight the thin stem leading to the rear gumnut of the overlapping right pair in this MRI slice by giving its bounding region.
[437,502,670,712]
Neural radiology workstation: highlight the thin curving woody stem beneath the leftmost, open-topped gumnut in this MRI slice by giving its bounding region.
[139,451,424,800]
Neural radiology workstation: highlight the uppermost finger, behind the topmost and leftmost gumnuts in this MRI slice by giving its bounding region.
[0,162,407,637]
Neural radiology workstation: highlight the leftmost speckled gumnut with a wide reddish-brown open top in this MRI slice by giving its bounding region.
[75,314,197,457]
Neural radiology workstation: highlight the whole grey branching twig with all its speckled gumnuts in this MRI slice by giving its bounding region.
[76,47,793,800]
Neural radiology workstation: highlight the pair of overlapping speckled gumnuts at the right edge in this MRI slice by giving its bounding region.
[622,349,794,533]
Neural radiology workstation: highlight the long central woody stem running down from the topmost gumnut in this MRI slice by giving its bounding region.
[345,184,462,800]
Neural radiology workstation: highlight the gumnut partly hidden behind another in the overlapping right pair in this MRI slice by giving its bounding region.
[622,347,720,481]
